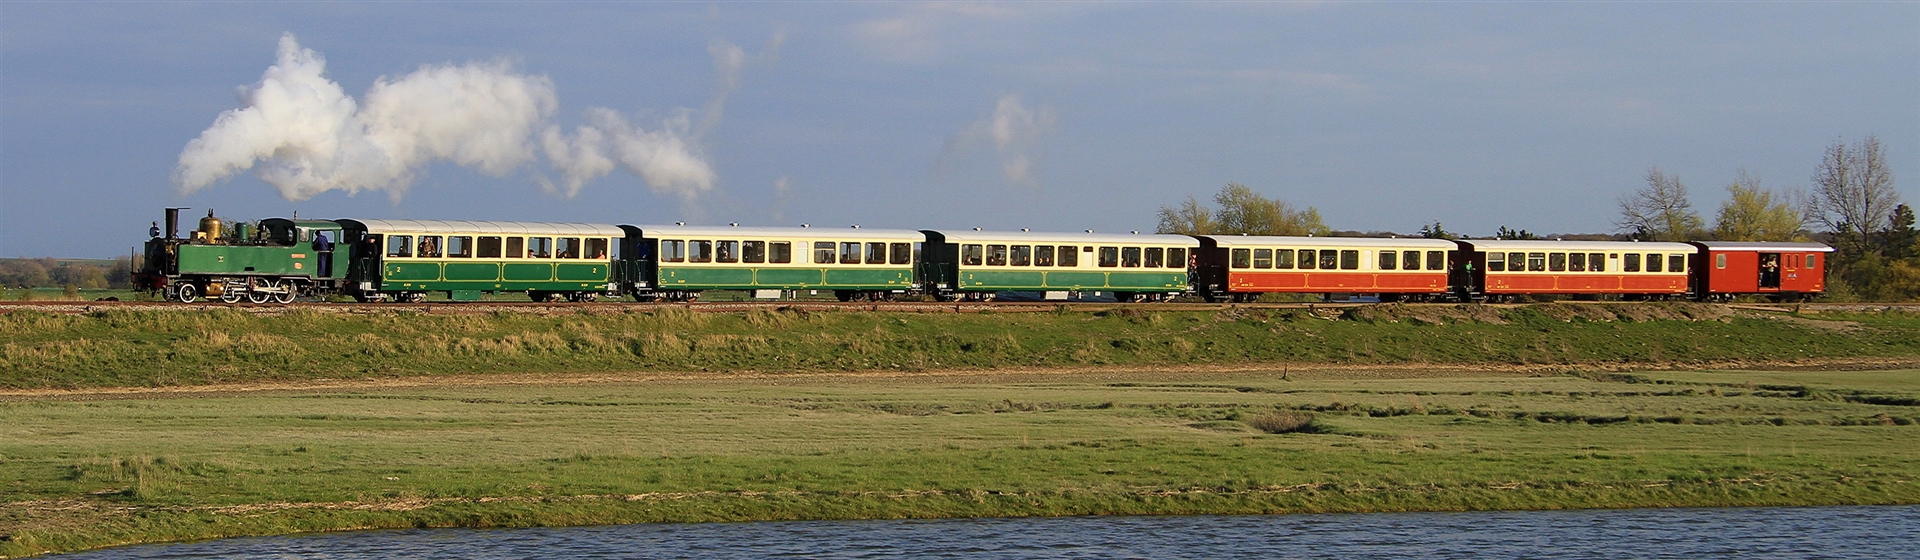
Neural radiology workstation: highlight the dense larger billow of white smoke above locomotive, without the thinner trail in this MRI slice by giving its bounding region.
[173,35,557,199]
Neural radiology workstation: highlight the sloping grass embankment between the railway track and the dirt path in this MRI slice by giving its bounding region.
[0,303,1920,389]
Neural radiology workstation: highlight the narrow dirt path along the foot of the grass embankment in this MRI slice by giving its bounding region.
[0,357,1920,401]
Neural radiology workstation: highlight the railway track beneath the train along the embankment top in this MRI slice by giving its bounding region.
[0,301,1920,315]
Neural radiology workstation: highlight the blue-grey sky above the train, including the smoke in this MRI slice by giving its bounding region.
[0,2,1920,257]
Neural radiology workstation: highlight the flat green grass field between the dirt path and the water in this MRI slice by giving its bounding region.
[0,366,1920,556]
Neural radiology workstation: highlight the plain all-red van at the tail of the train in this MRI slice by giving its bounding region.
[1692,242,1834,301]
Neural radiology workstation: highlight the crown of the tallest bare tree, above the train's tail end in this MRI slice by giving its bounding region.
[1809,134,1901,240]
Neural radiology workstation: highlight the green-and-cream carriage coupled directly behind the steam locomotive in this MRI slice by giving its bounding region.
[338,221,624,301]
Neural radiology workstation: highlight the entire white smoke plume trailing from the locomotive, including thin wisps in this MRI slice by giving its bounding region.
[173,35,741,201]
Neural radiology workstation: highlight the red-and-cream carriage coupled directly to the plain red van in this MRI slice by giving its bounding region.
[1453,240,1697,301]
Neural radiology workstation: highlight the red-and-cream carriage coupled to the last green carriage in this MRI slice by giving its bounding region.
[1194,236,1457,301]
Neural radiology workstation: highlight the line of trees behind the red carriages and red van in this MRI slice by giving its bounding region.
[1158,136,1920,301]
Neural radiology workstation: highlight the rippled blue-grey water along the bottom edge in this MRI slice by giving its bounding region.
[67,506,1920,558]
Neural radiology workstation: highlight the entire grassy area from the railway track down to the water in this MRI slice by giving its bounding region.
[0,303,1920,556]
